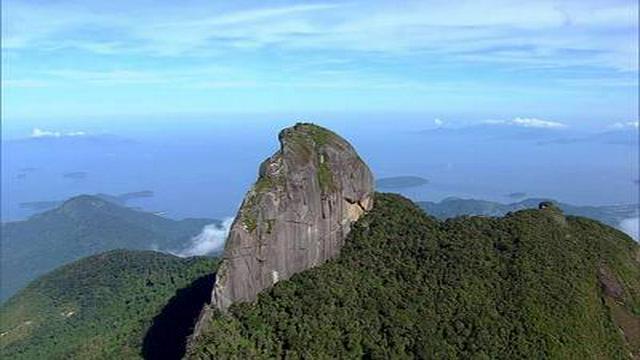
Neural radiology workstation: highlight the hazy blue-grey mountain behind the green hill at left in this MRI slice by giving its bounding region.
[0,195,214,300]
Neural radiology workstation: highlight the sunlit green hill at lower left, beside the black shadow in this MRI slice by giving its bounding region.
[0,250,216,359]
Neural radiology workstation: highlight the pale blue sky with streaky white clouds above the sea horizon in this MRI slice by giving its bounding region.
[2,0,638,128]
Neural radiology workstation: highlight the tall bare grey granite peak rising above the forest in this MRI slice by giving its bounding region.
[211,124,374,317]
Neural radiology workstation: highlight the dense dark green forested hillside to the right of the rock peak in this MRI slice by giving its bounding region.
[188,195,640,359]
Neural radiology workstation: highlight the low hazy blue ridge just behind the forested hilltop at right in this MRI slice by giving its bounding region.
[417,197,640,227]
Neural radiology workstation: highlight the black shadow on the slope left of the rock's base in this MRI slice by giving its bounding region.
[142,274,215,360]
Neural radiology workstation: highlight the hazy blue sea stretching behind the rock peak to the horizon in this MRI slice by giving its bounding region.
[2,117,640,221]
